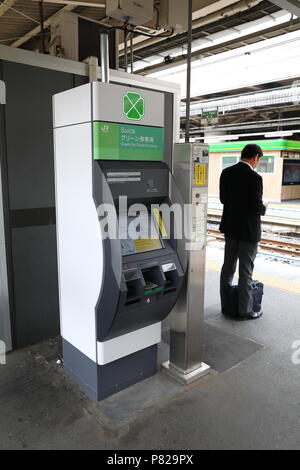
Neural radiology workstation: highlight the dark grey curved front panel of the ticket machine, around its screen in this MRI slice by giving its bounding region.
[93,161,184,341]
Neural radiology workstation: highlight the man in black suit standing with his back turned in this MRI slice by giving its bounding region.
[220,144,267,319]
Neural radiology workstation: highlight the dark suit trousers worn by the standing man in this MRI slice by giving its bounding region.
[220,235,258,316]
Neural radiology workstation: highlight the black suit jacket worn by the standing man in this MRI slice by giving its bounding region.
[220,162,266,243]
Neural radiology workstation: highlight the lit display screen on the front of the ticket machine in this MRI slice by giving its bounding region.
[119,212,163,256]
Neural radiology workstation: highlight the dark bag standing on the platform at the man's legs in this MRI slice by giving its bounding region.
[222,281,264,317]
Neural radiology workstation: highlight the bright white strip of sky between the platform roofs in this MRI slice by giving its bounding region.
[149,29,300,99]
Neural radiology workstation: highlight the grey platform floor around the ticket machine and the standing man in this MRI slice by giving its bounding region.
[0,244,300,450]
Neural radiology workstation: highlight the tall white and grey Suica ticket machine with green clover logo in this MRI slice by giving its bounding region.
[53,82,186,400]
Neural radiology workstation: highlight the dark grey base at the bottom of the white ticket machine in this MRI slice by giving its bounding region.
[63,339,157,401]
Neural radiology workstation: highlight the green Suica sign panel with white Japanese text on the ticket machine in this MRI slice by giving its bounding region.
[93,121,164,161]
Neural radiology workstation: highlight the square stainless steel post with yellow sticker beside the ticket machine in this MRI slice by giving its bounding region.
[162,142,210,384]
